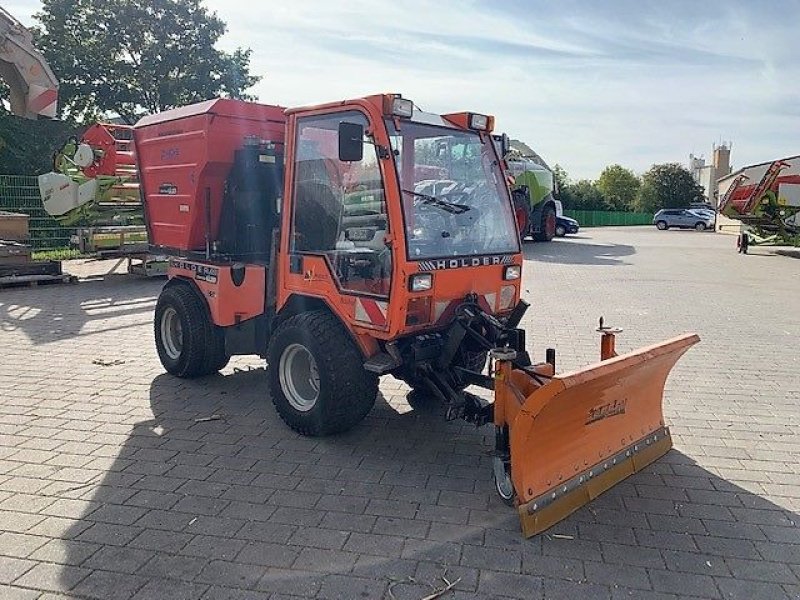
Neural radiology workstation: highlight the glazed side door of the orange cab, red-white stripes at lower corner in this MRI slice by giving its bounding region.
[286,110,393,329]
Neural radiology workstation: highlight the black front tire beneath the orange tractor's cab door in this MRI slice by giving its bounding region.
[267,311,378,436]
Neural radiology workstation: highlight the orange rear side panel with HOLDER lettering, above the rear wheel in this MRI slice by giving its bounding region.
[167,259,267,327]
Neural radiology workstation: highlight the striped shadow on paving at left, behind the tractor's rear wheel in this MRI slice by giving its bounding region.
[0,274,164,345]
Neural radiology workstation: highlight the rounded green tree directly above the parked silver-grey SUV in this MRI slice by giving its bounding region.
[636,163,704,213]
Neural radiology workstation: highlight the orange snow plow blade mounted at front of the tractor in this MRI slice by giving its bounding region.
[495,334,700,537]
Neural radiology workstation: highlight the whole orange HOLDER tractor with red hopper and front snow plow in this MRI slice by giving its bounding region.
[134,94,697,535]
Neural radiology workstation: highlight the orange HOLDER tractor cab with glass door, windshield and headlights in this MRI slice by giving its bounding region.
[278,94,522,344]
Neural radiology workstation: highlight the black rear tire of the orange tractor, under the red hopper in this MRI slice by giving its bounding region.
[153,284,222,379]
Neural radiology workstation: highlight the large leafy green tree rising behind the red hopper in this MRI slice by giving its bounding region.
[35,0,260,122]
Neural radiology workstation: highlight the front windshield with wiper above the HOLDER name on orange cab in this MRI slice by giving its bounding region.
[386,120,519,260]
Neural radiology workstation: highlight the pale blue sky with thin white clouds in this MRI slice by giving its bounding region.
[3,0,800,179]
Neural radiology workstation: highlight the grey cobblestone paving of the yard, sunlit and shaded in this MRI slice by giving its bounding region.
[0,228,800,600]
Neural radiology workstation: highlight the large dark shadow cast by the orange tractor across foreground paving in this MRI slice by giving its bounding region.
[53,370,800,600]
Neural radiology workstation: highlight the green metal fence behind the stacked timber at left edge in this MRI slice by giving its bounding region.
[0,175,75,250]
